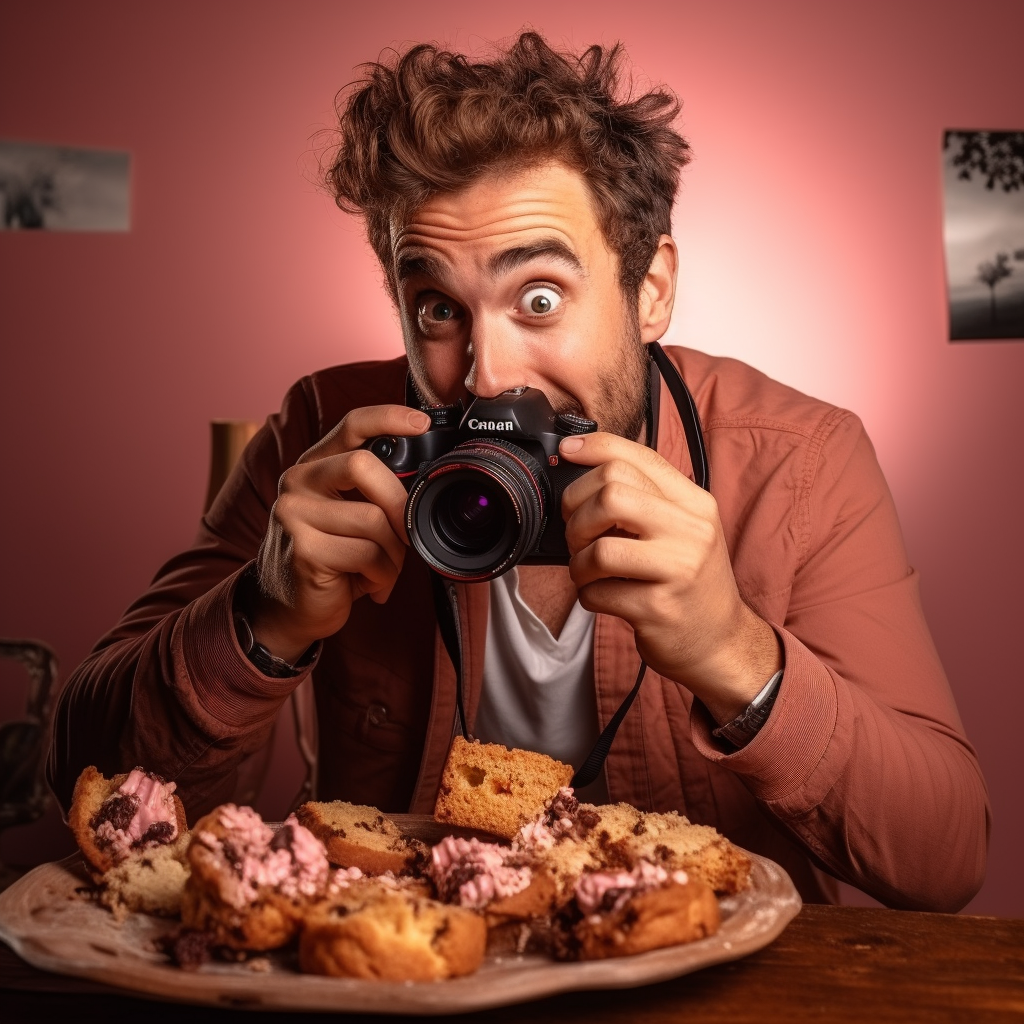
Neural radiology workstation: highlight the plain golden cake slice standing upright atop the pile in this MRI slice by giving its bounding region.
[434,736,572,839]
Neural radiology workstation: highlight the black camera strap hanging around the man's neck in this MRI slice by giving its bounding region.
[421,341,711,790]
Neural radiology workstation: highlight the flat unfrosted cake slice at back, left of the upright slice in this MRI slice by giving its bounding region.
[295,800,427,874]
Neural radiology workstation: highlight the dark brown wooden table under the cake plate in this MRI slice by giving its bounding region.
[0,906,1024,1024]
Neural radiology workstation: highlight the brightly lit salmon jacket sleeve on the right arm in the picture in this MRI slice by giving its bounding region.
[691,414,989,910]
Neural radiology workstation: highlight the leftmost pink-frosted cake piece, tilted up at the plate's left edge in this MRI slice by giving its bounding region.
[68,765,188,874]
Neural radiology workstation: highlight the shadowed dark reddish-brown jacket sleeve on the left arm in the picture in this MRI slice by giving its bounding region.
[47,378,319,817]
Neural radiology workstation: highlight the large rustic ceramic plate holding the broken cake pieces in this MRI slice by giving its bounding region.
[0,815,801,1014]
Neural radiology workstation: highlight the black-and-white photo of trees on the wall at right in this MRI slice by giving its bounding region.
[943,130,1024,341]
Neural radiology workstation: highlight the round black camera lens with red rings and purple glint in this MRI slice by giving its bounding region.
[406,438,549,582]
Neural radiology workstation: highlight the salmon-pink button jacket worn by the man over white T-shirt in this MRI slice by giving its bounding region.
[48,348,988,910]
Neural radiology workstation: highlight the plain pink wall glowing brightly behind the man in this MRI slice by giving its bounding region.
[0,0,1024,916]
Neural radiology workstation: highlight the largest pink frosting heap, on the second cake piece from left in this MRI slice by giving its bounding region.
[197,804,330,909]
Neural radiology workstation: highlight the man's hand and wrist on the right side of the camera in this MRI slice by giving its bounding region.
[560,431,782,724]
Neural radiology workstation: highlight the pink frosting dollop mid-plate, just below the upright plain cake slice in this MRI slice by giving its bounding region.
[427,836,534,910]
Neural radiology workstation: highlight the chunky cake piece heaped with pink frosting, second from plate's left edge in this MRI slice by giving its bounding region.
[181,804,332,950]
